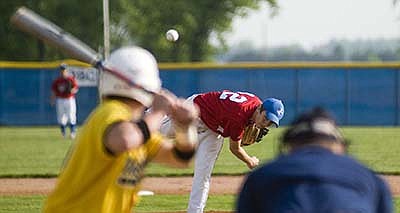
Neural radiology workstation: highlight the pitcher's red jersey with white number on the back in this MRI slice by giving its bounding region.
[194,90,262,141]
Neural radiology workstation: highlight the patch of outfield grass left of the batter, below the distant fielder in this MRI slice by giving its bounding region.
[0,127,71,177]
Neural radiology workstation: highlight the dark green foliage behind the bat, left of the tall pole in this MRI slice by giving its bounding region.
[0,0,104,61]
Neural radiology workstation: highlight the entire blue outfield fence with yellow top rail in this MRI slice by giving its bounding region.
[0,62,400,126]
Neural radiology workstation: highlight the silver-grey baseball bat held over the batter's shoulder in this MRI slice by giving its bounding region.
[10,7,151,93]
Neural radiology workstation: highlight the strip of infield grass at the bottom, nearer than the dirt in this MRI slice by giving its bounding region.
[0,195,400,213]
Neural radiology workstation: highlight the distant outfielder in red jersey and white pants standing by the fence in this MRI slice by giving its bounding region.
[51,64,78,139]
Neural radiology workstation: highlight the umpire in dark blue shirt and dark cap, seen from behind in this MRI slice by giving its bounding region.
[237,108,393,213]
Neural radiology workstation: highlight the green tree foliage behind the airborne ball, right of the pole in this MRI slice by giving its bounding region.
[116,0,276,62]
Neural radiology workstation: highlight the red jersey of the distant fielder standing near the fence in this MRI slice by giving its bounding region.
[51,76,78,98]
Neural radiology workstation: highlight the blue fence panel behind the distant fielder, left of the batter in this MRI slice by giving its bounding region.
[0,69,97,125]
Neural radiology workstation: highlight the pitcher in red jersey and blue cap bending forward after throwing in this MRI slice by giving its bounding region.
[161,90,284,213]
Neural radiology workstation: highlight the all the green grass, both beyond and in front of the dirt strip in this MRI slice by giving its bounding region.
[0,127,400,213]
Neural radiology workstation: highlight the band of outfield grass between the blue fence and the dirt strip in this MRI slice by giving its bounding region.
[0,127,400,177]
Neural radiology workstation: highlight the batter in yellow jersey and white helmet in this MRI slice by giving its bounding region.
[44,47,197,213]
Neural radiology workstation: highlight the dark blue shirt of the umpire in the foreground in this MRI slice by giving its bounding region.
[237,146,393,213]
